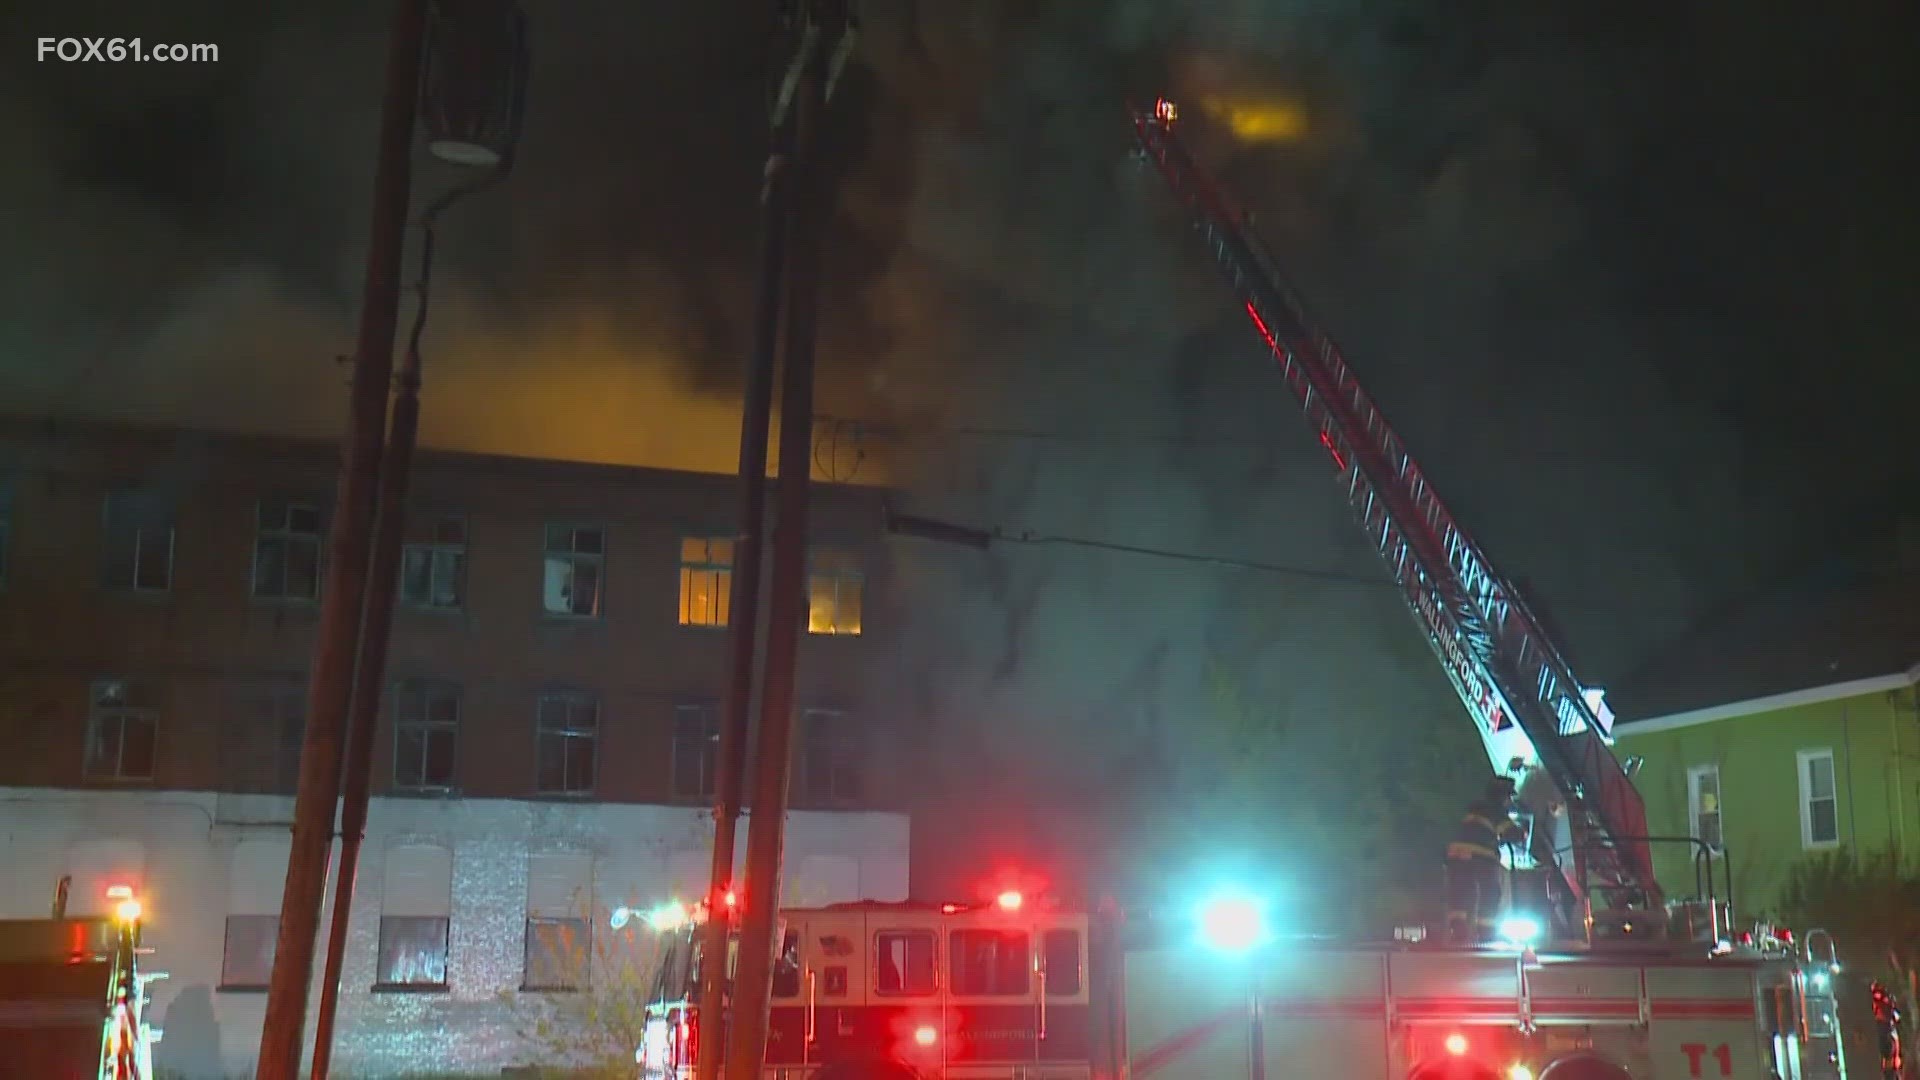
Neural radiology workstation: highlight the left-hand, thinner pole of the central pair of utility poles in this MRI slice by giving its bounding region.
[693,67,791,1080]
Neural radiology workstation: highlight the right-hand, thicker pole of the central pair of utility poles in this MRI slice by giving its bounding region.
[712,0,852,1080]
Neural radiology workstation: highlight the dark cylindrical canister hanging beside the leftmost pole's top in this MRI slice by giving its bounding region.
[420,0,530,169]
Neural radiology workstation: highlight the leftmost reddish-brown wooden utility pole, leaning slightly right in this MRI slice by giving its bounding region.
[255,0,426,1080]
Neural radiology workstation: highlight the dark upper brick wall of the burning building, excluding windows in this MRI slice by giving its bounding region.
[0,417,899,805]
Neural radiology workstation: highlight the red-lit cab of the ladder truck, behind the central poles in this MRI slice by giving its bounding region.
[637,894,1094,1080]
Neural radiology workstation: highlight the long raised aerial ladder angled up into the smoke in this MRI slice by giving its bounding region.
[1133,98,1663,932]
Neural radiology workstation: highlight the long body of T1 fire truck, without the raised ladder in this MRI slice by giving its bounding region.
[636,894,1845,1080]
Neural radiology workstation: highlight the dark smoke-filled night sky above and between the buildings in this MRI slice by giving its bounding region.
[0,0,1920,822]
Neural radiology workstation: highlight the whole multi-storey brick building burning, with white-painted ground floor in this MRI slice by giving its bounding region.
[0,423,908,1076]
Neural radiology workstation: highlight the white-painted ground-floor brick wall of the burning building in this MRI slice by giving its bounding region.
[0,788,908,1080]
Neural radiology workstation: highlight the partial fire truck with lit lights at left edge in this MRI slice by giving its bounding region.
[0,878,165,1080]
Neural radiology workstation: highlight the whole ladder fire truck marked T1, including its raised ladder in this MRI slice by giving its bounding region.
[636,98,1847,1080]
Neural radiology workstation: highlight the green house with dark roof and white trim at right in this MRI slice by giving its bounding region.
[1609,557,1920,917]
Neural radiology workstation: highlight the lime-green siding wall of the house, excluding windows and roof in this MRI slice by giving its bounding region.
[1615,686,1920,917]
